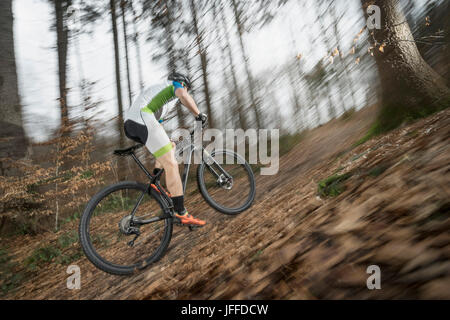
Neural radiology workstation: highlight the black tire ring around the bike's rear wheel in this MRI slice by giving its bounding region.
[79,181,173,275]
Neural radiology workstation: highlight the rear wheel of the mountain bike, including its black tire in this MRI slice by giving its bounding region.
[79,181,172,275]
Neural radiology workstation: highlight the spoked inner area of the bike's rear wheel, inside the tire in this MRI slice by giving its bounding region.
[81,184,167,267]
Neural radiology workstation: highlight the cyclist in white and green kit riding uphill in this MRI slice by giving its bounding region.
[124,72,207,226]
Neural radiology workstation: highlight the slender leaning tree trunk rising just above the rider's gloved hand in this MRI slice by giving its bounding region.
[190,0,214,128]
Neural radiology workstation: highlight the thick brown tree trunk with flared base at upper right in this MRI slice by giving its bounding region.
[361,0,450,131]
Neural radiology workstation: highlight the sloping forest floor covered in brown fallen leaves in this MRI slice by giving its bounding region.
[0,107,450,299]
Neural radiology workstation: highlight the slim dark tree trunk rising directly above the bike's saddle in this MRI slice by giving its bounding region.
[109,0,125,148]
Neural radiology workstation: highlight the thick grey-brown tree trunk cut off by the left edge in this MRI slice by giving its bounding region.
[0,0,27,164]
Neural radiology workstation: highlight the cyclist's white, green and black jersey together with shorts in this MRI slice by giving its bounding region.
[124,81,183,158]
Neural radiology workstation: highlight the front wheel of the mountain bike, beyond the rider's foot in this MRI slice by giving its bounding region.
[197,150,255,215]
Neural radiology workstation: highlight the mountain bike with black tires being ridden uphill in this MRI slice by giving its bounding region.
[79,125,255,275]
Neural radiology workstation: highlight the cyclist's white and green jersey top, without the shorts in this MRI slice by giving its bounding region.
[125,81,178,124]
